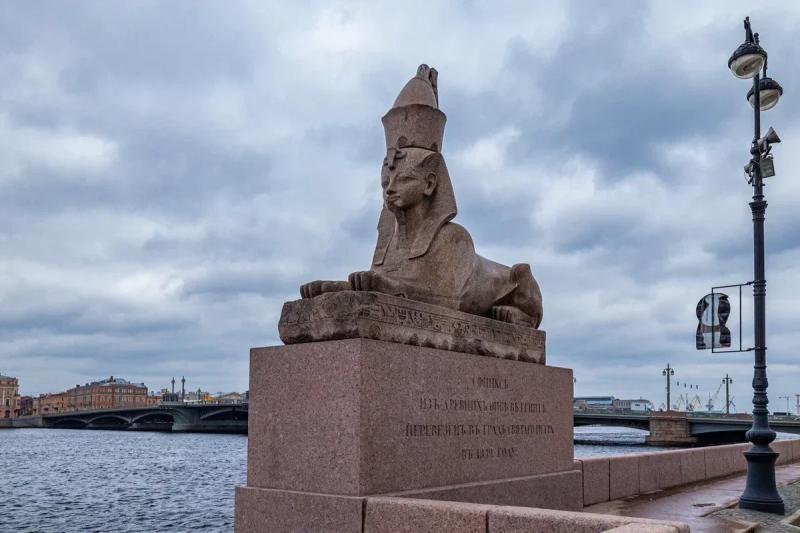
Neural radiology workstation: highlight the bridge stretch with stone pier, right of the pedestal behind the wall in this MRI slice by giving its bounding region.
[573,410,800,445]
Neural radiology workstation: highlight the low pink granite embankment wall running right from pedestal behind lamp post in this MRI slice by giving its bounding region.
[575,439,800,506]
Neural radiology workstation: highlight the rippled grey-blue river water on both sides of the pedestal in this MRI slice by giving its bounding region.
[0,427,780,533]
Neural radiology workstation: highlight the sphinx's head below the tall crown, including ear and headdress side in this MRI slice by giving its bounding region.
[381,148,443,214]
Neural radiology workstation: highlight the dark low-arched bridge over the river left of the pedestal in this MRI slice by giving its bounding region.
[36,402,248,433]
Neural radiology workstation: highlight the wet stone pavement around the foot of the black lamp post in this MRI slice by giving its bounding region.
[584,464,800,533]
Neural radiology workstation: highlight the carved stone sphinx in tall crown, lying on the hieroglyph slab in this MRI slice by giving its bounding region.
[300,65,542,328]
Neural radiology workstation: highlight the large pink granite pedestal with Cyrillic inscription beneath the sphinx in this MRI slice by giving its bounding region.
[236,339,583,533]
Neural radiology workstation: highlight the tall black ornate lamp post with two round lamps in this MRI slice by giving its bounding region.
[728,17,784,514]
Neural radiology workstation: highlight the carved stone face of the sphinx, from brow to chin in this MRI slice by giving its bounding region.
[381,149,436,212]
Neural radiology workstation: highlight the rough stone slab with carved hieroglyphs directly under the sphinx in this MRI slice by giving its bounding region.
[278,291,545,364]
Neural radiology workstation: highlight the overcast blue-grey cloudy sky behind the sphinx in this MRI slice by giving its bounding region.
[0,0,800,410]
